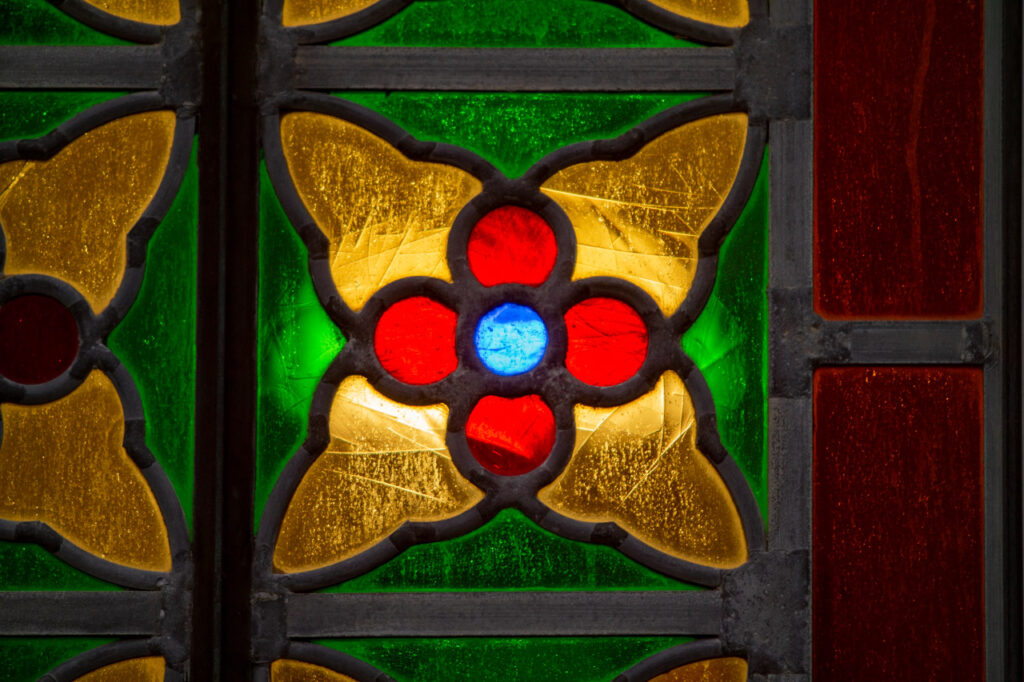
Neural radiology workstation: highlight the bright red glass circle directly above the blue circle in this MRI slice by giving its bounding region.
[467,206,558,287]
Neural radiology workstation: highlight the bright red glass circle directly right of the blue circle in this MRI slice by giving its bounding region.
[565,298,647,386]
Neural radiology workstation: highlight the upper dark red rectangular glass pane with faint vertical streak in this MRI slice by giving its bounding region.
[814,0,984,318]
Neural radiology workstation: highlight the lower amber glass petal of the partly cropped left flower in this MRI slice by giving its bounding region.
[0,370,171,570]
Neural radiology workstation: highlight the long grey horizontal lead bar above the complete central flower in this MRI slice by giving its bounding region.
[293,46,736,92]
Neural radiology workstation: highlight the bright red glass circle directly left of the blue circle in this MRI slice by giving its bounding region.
[374,296,459,384]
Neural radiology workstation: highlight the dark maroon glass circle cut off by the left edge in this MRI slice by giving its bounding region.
[0,294,78,384]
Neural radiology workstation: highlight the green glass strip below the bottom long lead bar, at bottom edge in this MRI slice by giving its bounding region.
[316,637,690,682]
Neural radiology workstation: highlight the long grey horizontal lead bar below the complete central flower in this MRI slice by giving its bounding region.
[287,591,722,637]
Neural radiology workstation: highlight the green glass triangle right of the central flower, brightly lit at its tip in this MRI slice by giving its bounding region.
[683,155,768,513]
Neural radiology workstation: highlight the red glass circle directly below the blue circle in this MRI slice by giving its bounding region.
[466,395,555,476]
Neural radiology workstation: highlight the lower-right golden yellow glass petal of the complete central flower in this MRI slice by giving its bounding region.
[538,372,746,568]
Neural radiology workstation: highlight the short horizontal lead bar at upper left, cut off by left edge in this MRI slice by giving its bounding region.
[0,45,164,90]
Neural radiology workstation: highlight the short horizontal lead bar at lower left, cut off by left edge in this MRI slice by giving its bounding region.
[0,592,161,636]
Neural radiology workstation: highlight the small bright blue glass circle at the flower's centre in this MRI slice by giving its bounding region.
[473,303,548,377]
